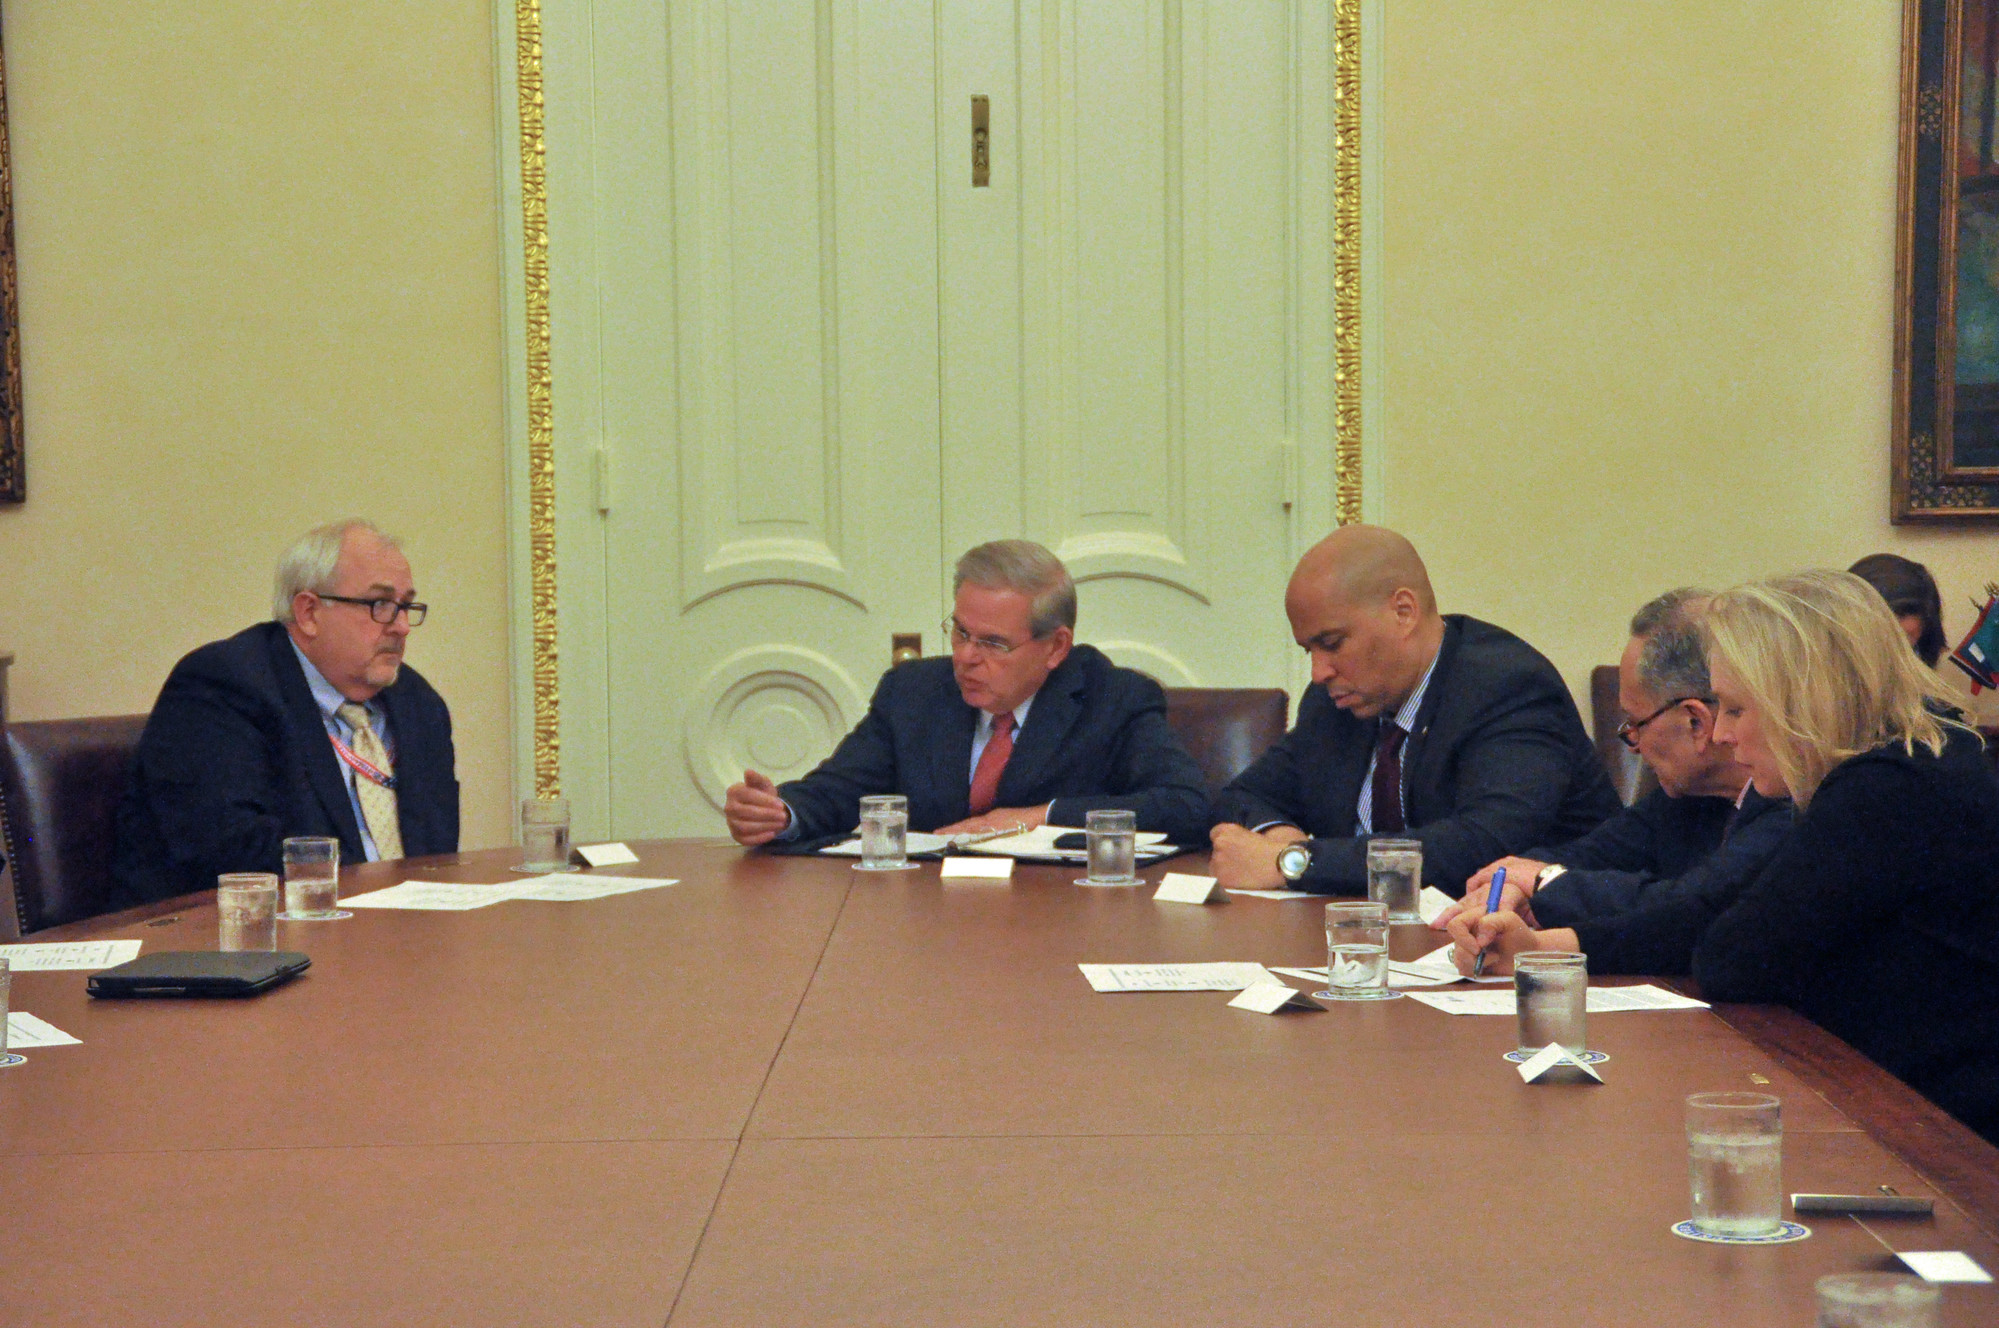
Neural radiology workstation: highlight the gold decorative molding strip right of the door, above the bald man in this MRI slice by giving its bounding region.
[1333,0,1361,526]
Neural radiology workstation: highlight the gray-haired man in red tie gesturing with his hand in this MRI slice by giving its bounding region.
[724,540,1207,846]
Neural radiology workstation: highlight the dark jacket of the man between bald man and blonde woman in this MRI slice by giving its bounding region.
[1527,788,1793,974]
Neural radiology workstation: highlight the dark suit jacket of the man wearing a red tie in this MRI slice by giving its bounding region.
[778,646,1207,844]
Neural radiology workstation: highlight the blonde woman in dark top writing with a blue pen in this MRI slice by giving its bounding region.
[1453,572,1999,1142]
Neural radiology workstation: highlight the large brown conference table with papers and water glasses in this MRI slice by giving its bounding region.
[0,842,1999,1328]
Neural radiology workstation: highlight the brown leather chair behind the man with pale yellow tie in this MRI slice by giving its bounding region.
[0,714,146,936]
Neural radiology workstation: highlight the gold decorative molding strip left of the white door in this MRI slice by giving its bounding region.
[514,0,562,798]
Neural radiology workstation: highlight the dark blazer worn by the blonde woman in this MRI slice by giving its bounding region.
[1679,742,1999,1144]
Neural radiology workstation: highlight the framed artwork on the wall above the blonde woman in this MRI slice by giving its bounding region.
[1891,0,1999,522]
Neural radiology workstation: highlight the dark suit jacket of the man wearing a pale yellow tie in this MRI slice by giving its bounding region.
[112,622,458,906]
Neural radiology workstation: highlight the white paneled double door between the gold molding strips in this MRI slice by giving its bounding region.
[552,0,1331,836]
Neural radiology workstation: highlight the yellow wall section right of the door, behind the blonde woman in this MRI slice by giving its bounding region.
[1379,0,1999,716]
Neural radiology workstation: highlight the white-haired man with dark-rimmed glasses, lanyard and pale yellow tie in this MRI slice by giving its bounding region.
[112,520,458,904]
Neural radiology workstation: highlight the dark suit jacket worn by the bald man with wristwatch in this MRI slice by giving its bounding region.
[1215,614,1621,894]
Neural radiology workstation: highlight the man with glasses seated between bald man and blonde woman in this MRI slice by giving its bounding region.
[1433,588,1791,972]
